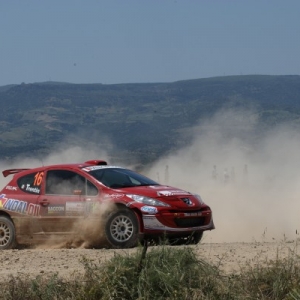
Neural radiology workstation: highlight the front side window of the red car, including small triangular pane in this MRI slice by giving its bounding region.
[46,170,98,196]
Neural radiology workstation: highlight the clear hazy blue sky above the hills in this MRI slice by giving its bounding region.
[0,0,300,86]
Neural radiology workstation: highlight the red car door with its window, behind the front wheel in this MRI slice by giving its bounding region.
[39,168,99,235]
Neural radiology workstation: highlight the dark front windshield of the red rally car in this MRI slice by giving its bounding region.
[89,168,158,188]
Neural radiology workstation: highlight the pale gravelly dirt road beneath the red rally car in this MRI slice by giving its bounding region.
[0,241,299,281]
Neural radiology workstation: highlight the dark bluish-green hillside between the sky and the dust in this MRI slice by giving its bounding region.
[0,75,300,162]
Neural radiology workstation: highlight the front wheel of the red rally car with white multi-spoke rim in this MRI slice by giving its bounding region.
[105,209,139,249]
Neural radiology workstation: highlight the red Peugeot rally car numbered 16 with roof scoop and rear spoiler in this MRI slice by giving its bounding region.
[0,160,214,249]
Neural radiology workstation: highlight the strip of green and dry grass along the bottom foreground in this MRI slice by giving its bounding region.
[0,245,300,300]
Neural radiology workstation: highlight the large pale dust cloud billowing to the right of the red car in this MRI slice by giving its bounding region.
[146,110,300,242]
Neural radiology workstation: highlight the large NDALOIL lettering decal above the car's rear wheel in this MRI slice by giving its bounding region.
[0,194,40,216]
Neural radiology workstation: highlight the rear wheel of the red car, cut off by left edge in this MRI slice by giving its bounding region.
[0,216,17,250]
